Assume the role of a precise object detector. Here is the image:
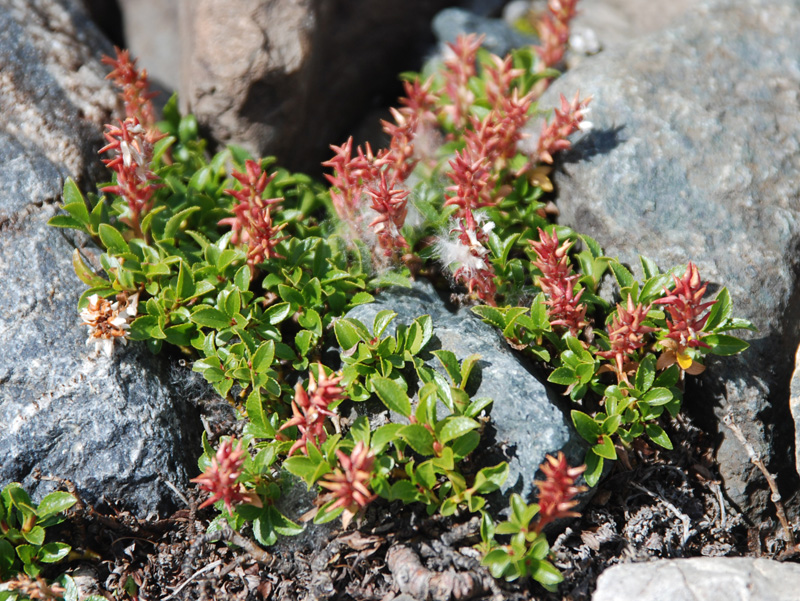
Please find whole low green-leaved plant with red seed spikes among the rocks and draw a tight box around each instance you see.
[51,7,752,588]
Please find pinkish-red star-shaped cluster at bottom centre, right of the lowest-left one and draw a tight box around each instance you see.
[319,441,375,528]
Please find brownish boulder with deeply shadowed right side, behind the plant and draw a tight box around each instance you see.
[180,0,456,172]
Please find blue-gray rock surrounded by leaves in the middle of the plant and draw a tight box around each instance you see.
[347,281,584,501]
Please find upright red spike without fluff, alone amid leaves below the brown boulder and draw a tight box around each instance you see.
[219,161,286,266]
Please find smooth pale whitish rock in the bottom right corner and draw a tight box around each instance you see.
[592,557,800,601]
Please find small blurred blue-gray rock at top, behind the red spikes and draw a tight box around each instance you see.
[433,8,536,56]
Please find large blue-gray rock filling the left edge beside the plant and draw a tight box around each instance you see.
[0,0,199,515]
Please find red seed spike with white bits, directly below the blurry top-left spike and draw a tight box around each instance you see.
[99,117,163,237]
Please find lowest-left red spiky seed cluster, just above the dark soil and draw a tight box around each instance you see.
[191,439,261,515]
